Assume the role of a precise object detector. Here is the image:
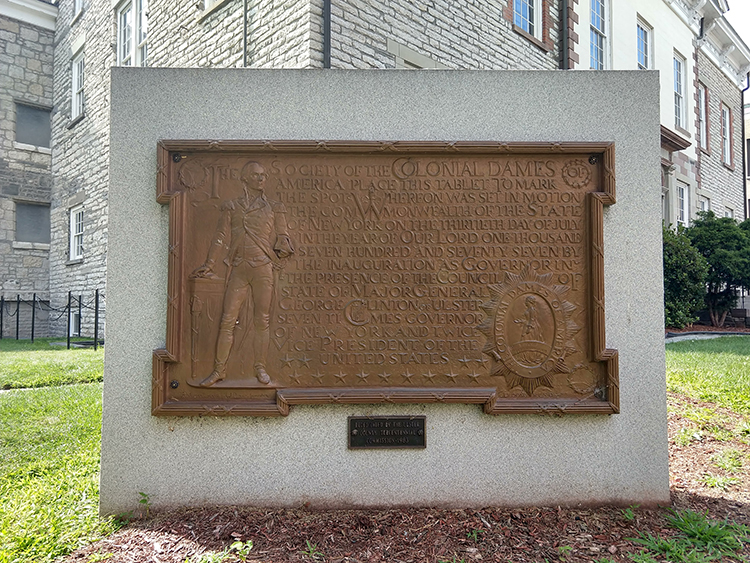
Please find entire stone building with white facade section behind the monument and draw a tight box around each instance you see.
[0,0,750,336]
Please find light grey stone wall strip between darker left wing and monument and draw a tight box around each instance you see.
[50,0,116,336]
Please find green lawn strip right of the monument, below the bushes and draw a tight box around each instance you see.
[667,336,750,414]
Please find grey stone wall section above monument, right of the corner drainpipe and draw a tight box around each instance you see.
[331,0,560,70]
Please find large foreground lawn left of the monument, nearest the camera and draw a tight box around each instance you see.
[0,383,116,563]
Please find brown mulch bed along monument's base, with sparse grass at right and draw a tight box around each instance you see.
[59,395,750,563]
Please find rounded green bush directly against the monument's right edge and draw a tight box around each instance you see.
[662,226,708,328]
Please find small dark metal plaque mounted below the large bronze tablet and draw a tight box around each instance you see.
[349,416,426,450]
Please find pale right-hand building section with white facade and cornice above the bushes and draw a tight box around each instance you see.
[574,0,750,229]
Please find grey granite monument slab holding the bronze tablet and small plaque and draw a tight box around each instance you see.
[101,68,669,513]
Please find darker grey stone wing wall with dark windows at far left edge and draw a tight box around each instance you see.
[0,12,54,335]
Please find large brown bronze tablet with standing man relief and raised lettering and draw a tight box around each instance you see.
[153,141,619,415]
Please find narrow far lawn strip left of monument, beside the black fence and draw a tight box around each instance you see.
[0,338,104,389]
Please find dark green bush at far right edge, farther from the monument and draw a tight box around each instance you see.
[686,211,750,326]
